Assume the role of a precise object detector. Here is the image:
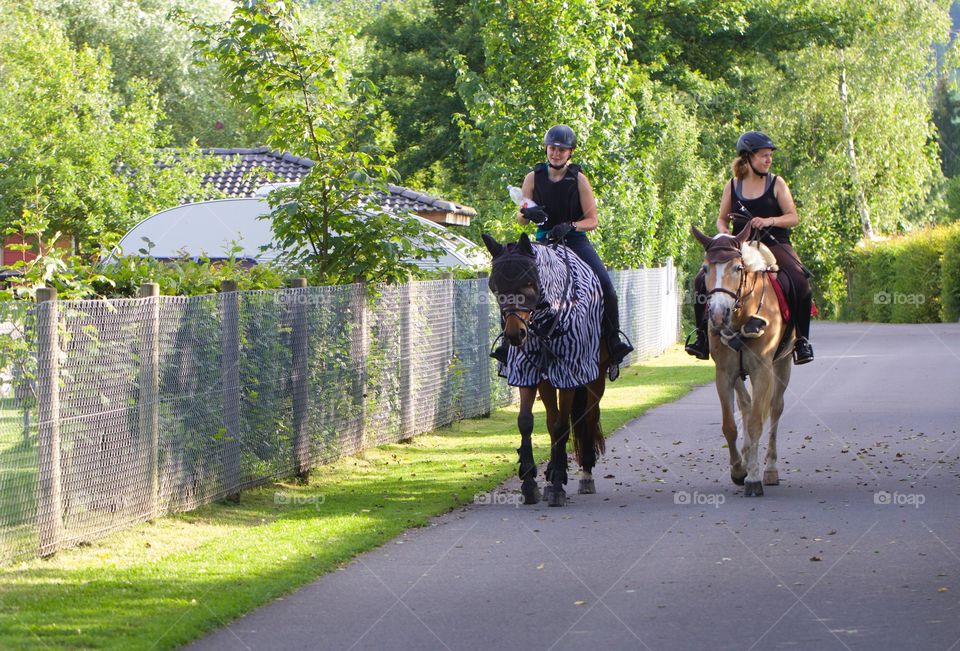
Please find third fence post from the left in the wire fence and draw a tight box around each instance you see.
[220,280,241,502]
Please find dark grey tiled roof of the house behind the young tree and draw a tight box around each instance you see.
[203,147,477,217]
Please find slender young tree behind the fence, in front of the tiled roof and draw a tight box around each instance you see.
[189,0,446,284]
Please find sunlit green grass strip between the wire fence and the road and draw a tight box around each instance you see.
[0,347,713,649]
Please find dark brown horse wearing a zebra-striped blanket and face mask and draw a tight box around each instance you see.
[483,234,607,506]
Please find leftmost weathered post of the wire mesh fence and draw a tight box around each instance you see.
[36,288,63,558]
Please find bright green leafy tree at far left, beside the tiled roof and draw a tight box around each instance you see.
[0,0,218,255]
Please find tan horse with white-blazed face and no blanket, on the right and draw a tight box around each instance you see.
[693,225,793,497]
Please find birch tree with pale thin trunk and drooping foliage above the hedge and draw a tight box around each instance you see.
[757,0,949,314]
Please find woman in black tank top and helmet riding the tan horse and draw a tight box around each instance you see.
[686,131,813,364]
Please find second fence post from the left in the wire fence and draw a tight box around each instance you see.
[140,283,160,520]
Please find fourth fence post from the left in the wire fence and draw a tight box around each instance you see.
[287,278,310,481]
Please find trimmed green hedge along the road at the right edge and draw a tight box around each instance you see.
[840,224,960,323]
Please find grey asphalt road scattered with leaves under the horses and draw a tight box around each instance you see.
[193,324,960,651]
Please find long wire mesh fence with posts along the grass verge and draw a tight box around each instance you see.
[0,265,680,563]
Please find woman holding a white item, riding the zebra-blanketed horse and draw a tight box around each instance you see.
[491,124,633,366]
